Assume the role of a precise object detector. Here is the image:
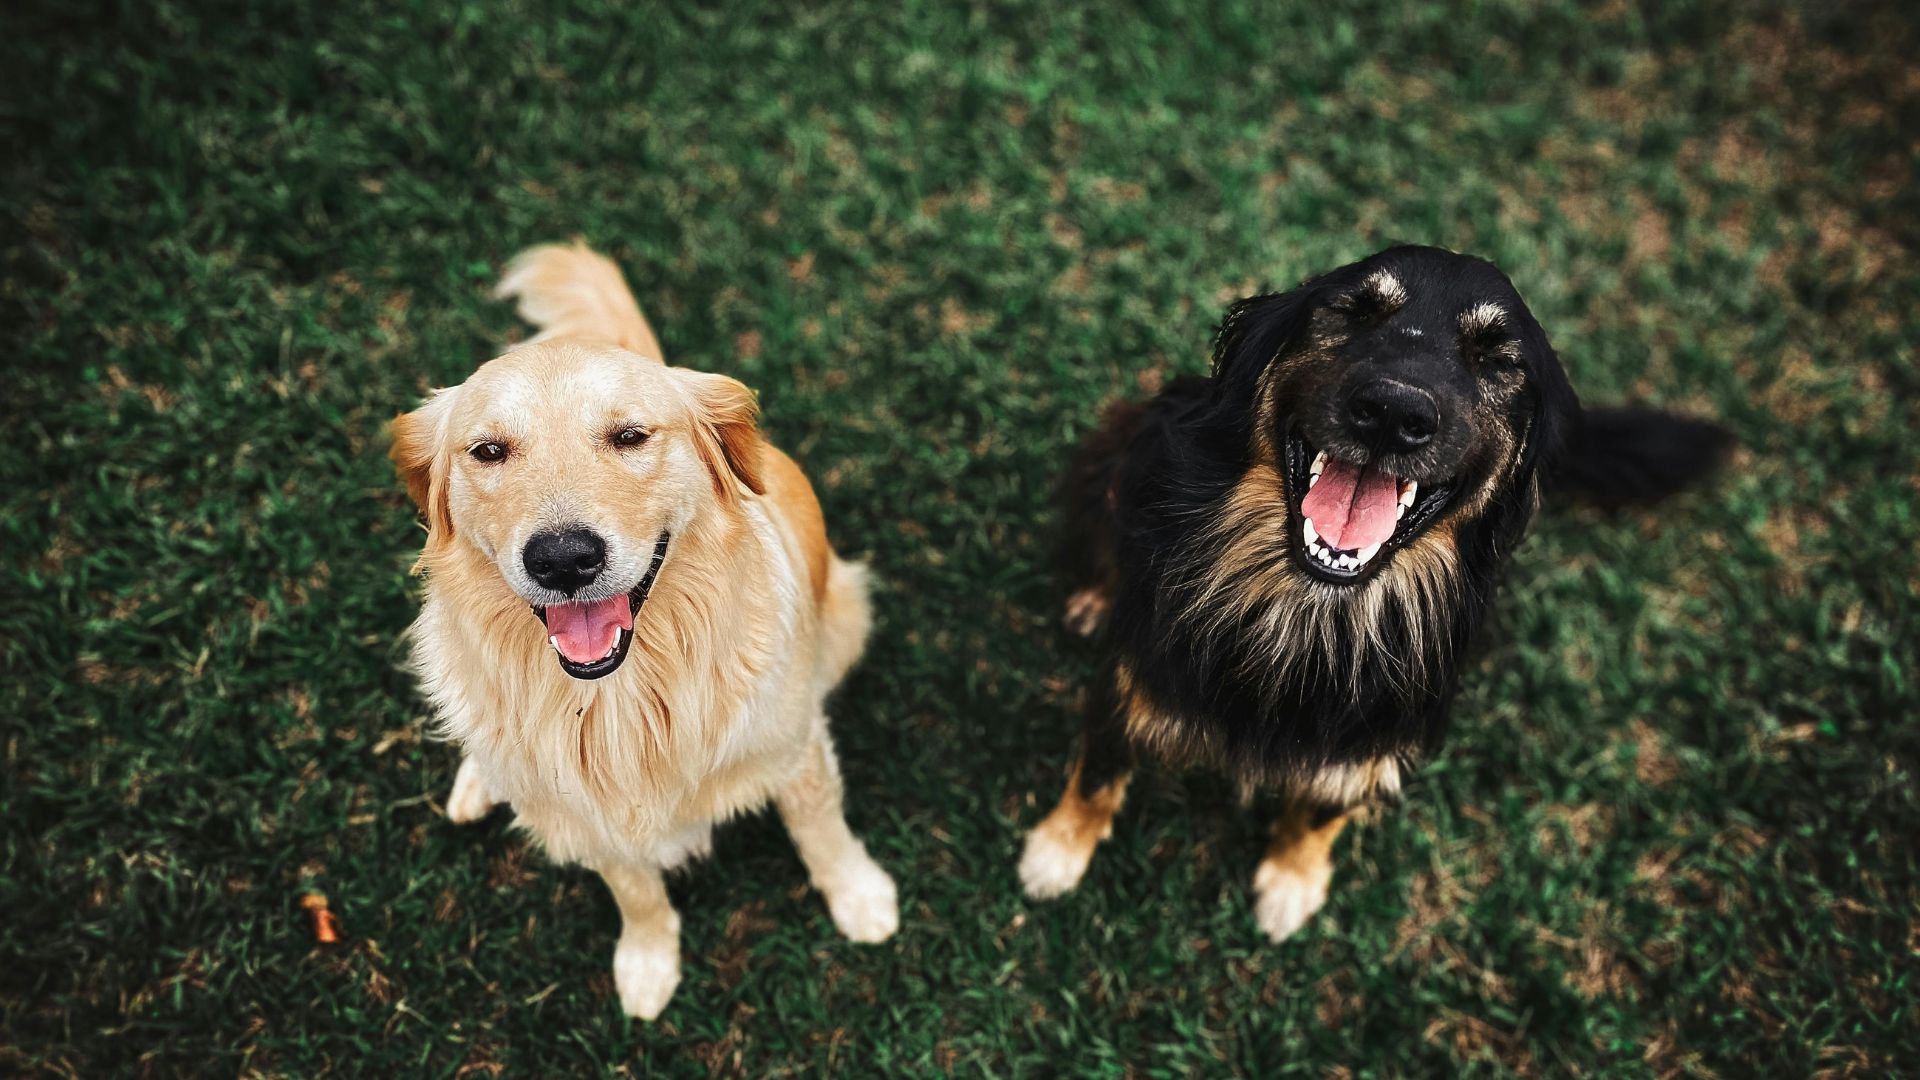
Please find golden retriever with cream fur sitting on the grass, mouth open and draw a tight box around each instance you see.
[392,244,899,1019]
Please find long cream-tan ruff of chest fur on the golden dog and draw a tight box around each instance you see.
[415,507,820,865]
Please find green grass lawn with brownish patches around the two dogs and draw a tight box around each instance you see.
[0,0,1920,1076]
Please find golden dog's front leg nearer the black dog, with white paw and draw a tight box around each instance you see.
[774,732,900,942]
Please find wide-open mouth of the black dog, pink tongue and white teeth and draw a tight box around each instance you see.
[1286,436,1452,584]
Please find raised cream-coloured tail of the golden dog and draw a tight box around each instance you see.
[493,240,666,363]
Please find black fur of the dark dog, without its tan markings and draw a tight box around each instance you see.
[1060,248,1726,799]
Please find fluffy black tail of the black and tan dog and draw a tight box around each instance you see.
[1553,409,1734,503]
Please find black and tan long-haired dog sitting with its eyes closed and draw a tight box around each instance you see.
[1020,248,1728,940]
